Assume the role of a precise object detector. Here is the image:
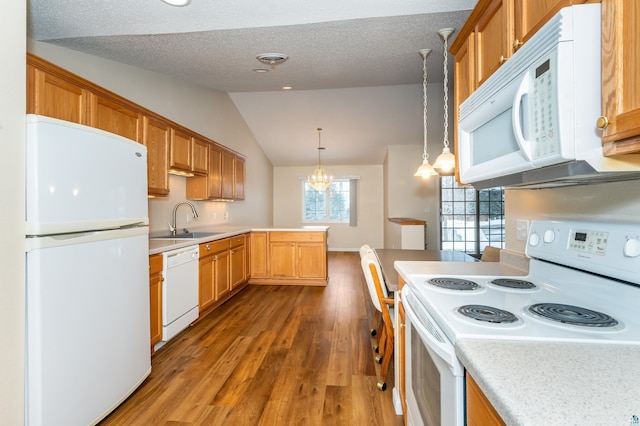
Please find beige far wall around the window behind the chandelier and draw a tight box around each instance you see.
[273,165,384,251]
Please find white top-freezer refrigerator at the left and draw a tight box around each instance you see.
[25,115,151,426]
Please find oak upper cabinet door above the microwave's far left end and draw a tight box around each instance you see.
[476,0,513,87]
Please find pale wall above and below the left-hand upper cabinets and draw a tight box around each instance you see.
[29,40,273,232]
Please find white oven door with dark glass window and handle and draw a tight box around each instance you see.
[402,285,465,426]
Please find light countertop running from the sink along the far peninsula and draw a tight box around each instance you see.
[149,225,329,255]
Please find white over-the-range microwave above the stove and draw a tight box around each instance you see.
[457,4,640,189]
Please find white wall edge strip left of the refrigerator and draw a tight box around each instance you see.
[0,0,27,425]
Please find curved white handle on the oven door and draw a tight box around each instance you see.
[402,286,464,376]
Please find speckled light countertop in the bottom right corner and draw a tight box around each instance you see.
[456,339,640,426]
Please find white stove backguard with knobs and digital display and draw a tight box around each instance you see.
[525,220,640,284]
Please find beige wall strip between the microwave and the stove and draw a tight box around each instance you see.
[505,181,640,253]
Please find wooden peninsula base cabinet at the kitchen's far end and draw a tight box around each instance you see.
[249,231,327,286]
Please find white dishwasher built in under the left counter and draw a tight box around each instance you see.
[161,245,199,347]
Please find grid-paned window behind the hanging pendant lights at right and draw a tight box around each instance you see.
[440,176,504,256]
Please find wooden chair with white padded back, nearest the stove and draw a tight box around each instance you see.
[361,251,395,391]
